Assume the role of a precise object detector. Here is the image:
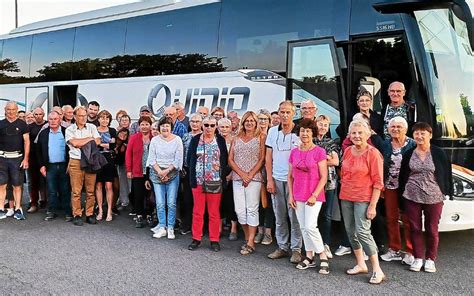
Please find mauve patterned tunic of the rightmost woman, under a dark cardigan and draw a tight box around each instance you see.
[403,152,444,204]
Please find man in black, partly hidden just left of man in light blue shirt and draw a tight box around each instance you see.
[28,107,46,213]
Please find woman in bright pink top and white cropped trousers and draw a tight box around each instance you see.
[288,119,329,274]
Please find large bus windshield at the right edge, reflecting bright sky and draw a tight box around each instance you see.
[415,9,474,139]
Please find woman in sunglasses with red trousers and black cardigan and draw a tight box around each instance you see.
[187,116,228,252]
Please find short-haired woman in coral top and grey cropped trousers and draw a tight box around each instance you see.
[339,120,385,284]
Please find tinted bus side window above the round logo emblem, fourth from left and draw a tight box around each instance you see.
[125,4,223,76]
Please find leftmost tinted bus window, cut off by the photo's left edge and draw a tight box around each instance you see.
[0,36,31,83]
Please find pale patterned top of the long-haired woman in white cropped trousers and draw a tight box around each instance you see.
[232,137,262,182]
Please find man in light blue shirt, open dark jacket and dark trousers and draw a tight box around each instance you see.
[36,111,72,222]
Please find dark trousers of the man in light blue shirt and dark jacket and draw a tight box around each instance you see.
[46,162,71,215]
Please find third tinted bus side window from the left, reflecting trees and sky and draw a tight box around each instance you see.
[72,20,127,79]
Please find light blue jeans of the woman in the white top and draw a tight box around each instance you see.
[153,176,179,228]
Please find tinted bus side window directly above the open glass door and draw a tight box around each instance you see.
[219,0,350,75]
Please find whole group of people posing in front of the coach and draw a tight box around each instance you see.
[0,82,452,284]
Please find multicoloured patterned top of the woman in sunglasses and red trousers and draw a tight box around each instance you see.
[196,136,221,185]
